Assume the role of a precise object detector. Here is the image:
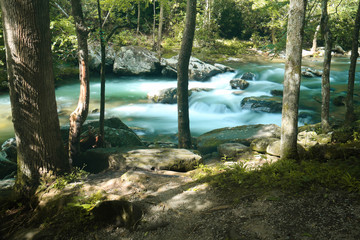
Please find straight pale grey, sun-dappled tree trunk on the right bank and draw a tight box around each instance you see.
[281,0,306,159]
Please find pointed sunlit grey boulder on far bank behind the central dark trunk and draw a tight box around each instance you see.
[162,56,225,81]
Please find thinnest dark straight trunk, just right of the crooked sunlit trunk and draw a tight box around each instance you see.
[97,0,105,147]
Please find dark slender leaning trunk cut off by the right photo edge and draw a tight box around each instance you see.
[345,1,360,124]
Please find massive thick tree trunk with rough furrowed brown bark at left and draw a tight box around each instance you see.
[1,0,69,196]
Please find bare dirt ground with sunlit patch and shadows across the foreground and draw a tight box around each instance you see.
[0,165,360,240]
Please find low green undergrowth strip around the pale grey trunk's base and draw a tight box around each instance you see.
[193,158,360,194]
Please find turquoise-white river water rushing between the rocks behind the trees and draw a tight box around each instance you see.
[0,58,360,142]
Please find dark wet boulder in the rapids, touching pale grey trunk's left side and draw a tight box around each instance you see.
[241,96,282,113]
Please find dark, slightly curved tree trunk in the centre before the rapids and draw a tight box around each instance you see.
[177,0,196,148]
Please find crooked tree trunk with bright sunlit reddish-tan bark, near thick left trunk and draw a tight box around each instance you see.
[69,0,90,164]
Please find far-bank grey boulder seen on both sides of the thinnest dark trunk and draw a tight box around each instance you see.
[89,43,116,72]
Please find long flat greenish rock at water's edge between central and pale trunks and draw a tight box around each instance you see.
[197,124,280,154]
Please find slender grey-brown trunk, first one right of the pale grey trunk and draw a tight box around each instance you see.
[321,0,332,132]
